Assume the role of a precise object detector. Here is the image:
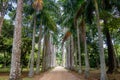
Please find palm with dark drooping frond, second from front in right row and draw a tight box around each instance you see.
[74,2,90,75]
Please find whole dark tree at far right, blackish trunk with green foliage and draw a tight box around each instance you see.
[101,0,120,73]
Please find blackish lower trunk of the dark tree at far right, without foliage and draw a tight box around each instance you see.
[105,27,117,73]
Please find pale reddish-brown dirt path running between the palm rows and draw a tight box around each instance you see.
[34,67,83,80]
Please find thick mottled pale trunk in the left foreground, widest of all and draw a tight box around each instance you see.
[9,0,23,80]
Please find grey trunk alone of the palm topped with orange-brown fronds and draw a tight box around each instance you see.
[28,15,36,77]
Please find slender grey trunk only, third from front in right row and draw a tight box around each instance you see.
[77,21,82,74]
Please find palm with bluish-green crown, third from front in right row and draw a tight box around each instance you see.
[62,0,82,73]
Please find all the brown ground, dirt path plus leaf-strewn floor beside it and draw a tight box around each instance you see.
[0,66,120,80]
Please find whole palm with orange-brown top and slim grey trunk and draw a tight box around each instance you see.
[28,0,43,77]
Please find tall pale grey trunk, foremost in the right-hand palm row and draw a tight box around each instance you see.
[94,0,107,80]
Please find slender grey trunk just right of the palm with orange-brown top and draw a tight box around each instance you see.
[36,23,42,74]
